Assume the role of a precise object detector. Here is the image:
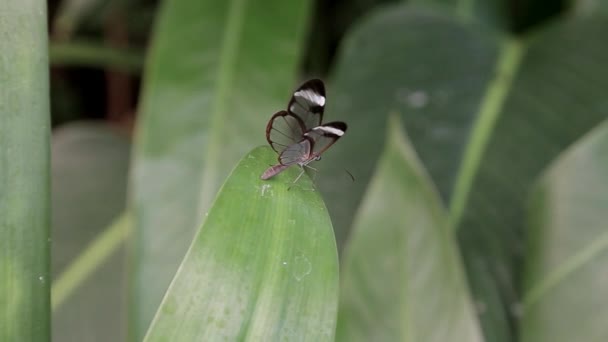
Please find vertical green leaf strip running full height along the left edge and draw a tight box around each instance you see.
[0,0,51,341]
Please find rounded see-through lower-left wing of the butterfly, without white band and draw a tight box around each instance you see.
[266,110,305,153]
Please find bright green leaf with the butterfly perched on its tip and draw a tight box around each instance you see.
[146,147,338,341]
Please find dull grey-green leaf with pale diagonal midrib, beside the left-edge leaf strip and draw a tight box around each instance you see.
[51,121,130,342]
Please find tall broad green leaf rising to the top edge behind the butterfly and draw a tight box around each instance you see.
[130,0,309,340]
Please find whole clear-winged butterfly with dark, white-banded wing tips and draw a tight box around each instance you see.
[261,79,346,183]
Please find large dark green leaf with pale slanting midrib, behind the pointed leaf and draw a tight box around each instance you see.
[319,5,608,341]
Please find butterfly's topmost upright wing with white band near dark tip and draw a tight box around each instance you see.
[287,79,325,131]
